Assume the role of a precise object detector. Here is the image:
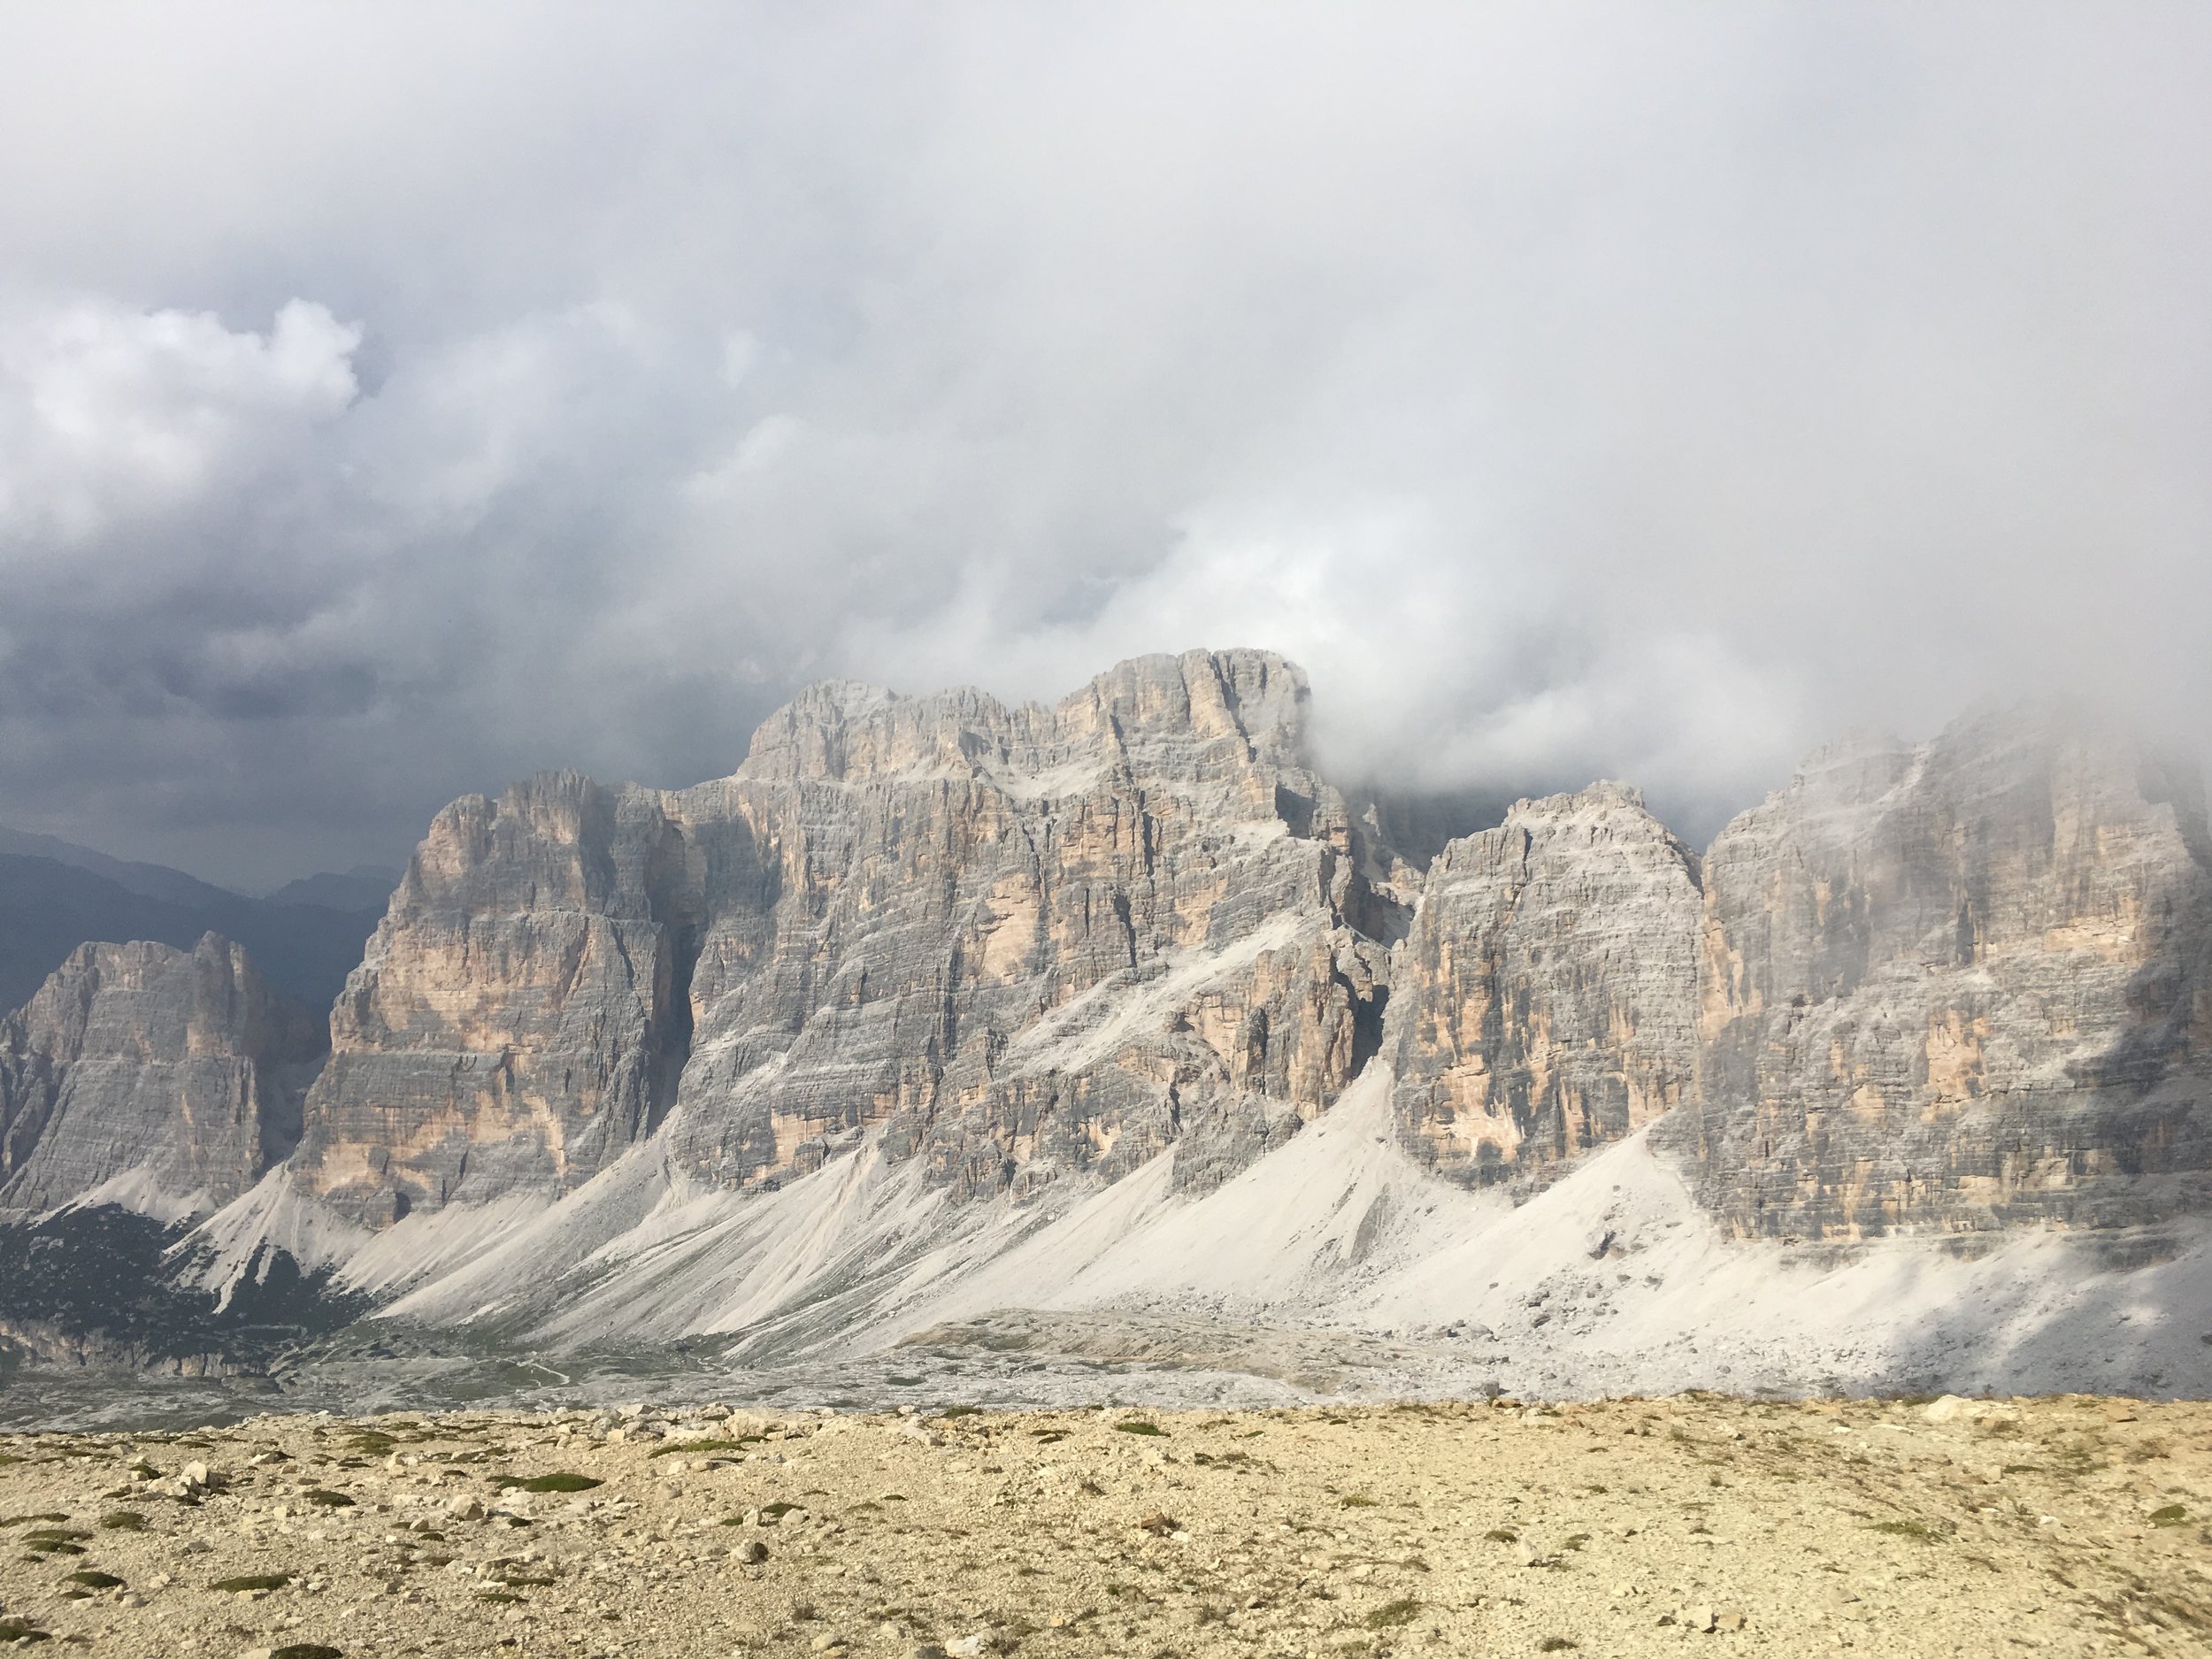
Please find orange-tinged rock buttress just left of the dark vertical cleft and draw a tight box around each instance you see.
[299,772,688,1221]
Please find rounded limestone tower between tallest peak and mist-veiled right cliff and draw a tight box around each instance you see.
[1385,783,1701,1184]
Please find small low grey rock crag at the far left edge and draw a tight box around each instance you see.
[0,933,323,1212]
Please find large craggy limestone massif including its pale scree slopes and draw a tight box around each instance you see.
[4,650,2212,1394]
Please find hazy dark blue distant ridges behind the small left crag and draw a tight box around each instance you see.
[0,849,383,1009]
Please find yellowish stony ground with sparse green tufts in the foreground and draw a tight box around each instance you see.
[0,1396,2212,1659]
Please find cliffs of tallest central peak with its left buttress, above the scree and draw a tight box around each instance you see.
[295,653,1396,1221]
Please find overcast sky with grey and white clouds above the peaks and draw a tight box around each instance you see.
[0,0,2212,889]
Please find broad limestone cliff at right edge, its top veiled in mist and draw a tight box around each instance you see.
[1663,708,2212,1239]
